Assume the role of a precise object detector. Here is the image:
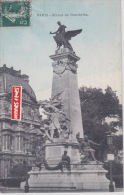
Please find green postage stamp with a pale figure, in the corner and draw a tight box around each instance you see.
[0,0,31,27]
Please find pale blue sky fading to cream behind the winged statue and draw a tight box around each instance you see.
[0,0,122,101]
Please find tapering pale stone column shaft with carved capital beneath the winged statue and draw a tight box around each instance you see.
[50,48,83,142]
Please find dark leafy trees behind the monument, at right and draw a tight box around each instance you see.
[79,86,123,160]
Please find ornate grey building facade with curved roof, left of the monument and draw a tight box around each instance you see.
[0,65,41,178]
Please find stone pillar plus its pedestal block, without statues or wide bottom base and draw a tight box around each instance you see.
[43,48,83,164]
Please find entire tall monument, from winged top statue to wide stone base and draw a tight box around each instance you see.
[22,22,109,192]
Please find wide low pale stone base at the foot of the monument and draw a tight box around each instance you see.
[21,164,109,192]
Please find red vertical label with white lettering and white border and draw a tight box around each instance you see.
[11,86,22,120]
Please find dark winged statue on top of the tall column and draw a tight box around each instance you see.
[50,22,82,51]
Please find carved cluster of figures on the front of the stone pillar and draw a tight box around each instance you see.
[39,93,70,142]
